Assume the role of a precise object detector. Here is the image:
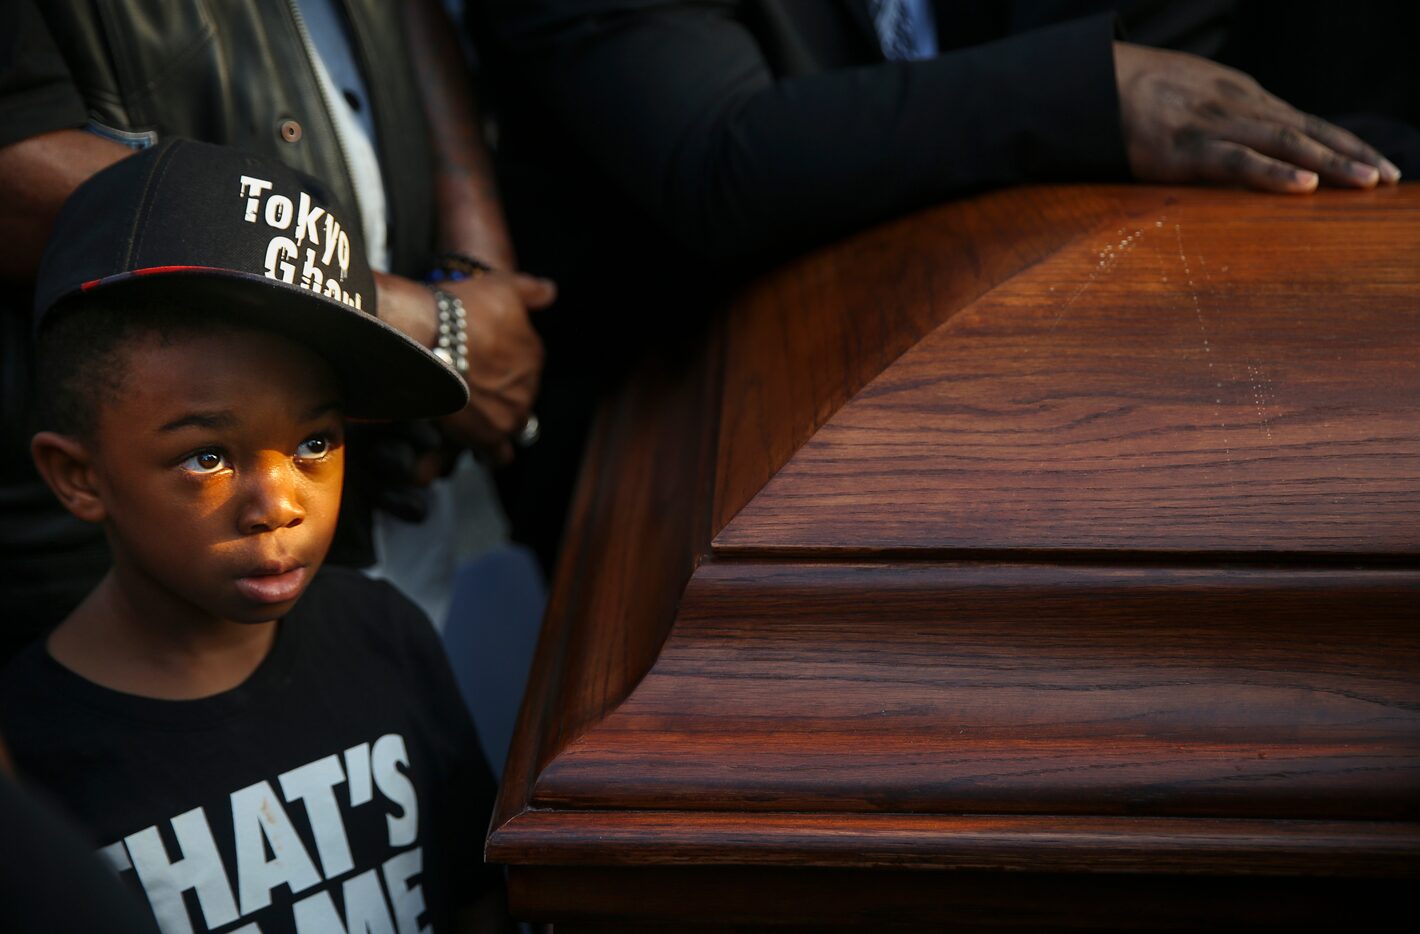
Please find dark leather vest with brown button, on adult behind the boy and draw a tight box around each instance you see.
[36,0,433,277]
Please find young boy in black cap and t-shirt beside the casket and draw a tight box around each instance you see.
[0,141,508,934]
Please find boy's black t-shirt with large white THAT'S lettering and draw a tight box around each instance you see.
[0,568,497,934]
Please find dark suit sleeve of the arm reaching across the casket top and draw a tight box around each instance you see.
[482,0,1125,258]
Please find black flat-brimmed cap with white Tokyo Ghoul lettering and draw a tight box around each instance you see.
[34,139,469,419]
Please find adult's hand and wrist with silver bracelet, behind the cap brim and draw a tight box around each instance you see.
[376,265,557,464]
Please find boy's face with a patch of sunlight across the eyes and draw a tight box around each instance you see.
[91,328,345,623]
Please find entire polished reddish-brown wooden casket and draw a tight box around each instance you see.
[487,186,1420,931]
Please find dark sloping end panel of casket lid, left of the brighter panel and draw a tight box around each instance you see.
[714,186,1137,531]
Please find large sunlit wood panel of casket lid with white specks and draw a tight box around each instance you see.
[716,187,1420,555]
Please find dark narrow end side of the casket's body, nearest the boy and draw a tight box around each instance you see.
[493,320,721,826]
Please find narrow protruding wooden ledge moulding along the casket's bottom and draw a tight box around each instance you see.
[493,811,1417,879]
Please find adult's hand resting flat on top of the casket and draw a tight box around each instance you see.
[1115,43,1400,193]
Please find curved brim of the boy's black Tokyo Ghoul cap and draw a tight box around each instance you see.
[70,267,469,419]
